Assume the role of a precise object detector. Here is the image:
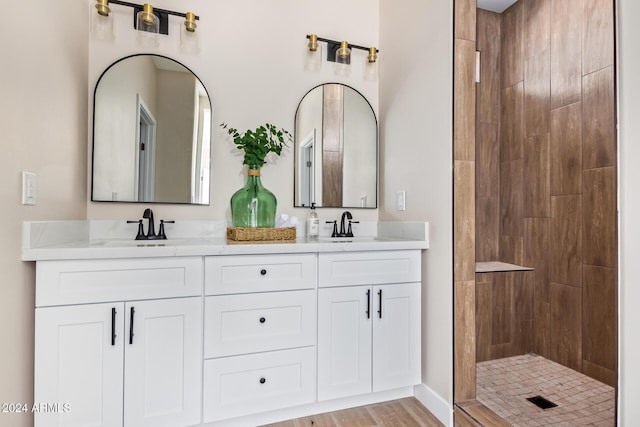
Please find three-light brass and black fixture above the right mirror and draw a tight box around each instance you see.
[306,34,380,78]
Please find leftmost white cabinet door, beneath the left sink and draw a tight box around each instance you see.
[34,303,124,427]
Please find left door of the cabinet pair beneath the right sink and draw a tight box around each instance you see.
[318,286,374,400]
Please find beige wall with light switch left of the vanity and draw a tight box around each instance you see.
[0,0,88,427]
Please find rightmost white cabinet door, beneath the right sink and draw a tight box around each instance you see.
[372,283,421,391]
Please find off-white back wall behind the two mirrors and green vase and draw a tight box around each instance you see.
[87,0,379,227]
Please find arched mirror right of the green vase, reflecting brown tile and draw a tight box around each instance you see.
[294,83,378,208]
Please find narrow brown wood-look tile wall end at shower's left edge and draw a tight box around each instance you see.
[453,0,478,401]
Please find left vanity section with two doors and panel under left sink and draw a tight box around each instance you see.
[34,257,202,427]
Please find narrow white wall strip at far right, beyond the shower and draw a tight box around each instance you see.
[617,0,640,426]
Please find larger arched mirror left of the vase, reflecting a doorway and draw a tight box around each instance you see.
[91,55,212,205]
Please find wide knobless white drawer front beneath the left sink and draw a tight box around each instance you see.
[36,257,203,307]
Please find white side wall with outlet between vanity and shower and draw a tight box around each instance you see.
[380,0,453,422]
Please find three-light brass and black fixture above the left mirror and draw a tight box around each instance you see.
[91,0,200,46]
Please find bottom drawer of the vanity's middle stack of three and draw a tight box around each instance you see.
[203,347,316,422]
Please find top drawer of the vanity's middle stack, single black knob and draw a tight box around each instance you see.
[205,254,316,295]
